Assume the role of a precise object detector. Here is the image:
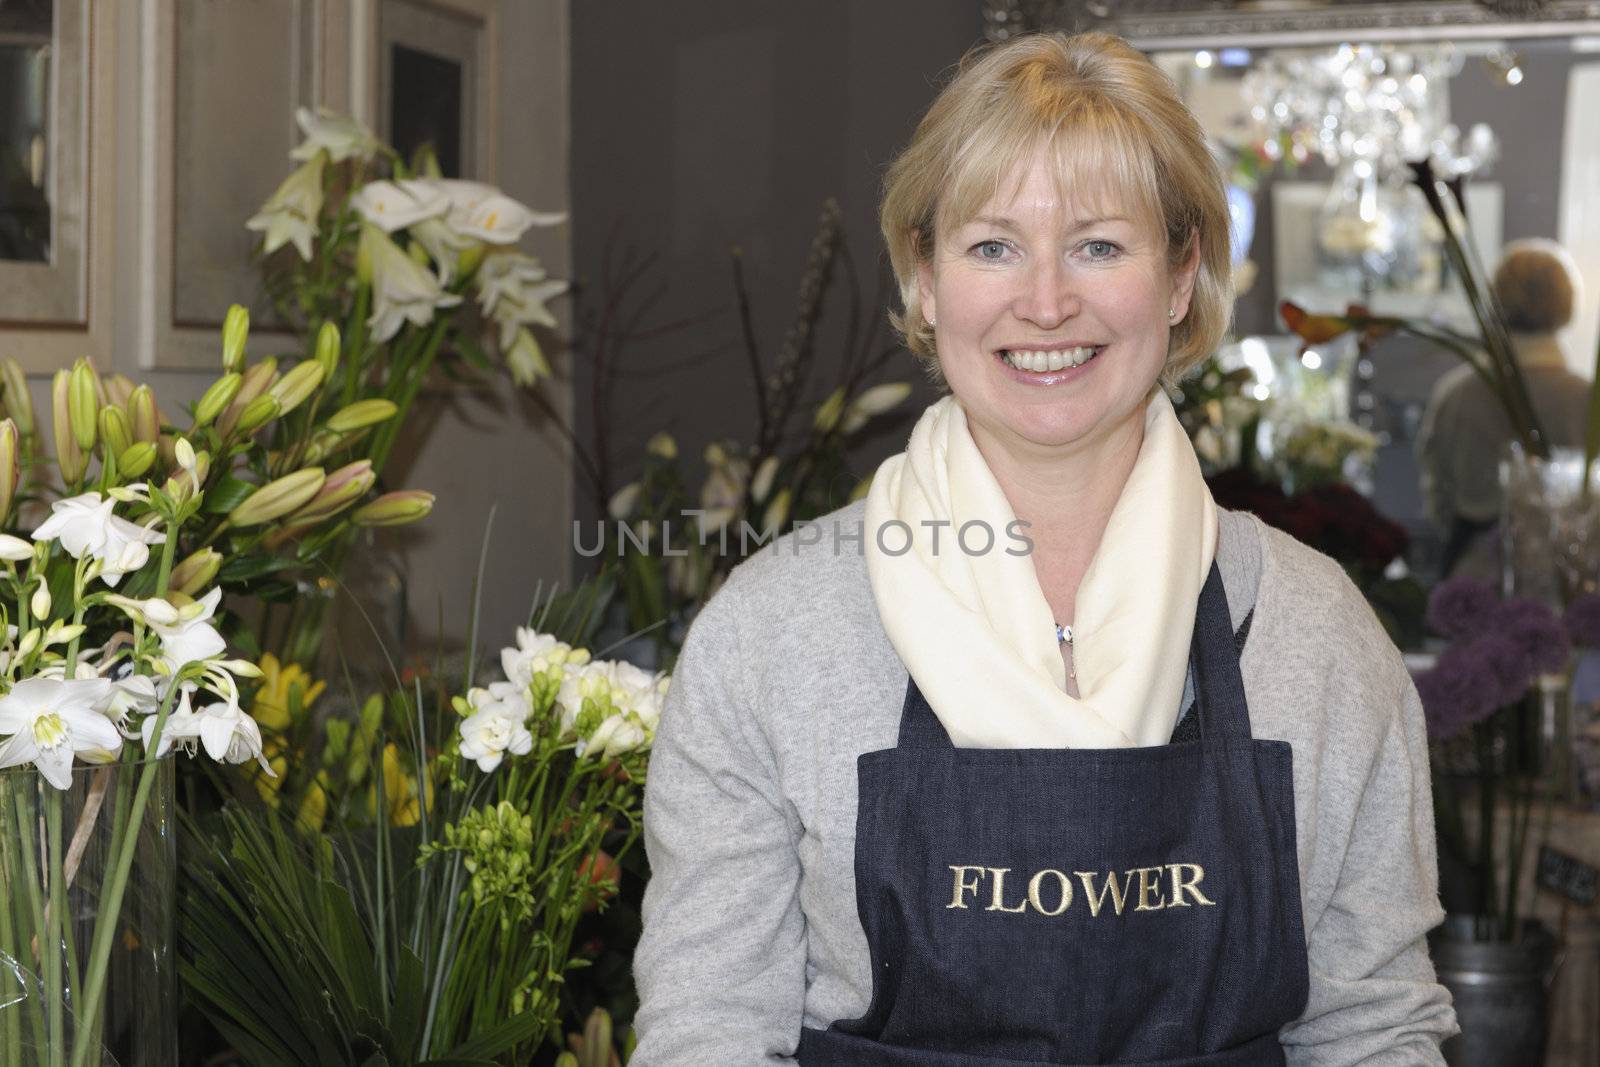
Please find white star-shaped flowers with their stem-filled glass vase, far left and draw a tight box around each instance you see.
[0,447,270,1067]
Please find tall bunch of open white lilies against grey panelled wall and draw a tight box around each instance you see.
[246,109,566,667]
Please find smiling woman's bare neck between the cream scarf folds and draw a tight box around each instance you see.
[973,406,1144,624]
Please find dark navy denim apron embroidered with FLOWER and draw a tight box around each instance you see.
[798,565,1309,1067]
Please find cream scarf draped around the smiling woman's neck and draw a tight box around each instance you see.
[866,389,1216,749]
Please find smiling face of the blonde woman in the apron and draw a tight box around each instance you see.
[918,154,1198,454]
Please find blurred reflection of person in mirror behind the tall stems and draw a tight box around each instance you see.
[1416,238,1589,577]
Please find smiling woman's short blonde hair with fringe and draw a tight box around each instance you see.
[878,34,1234,381]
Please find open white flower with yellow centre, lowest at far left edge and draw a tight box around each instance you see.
[0,678,122,789]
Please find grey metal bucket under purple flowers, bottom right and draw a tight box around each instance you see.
[1429,915,1555,1067]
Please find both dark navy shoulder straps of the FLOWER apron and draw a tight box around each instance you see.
[899,561,1250,749]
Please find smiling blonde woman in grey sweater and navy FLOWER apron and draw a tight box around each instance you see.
[632,35,1454,1067]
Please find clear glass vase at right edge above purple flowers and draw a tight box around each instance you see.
[1501,445,1600,609]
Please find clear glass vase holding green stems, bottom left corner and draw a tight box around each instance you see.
[0,757,178,1067]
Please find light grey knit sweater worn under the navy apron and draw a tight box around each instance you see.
[630,502,1456,1067]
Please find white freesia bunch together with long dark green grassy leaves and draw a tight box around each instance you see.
[179,620,667,1067]
